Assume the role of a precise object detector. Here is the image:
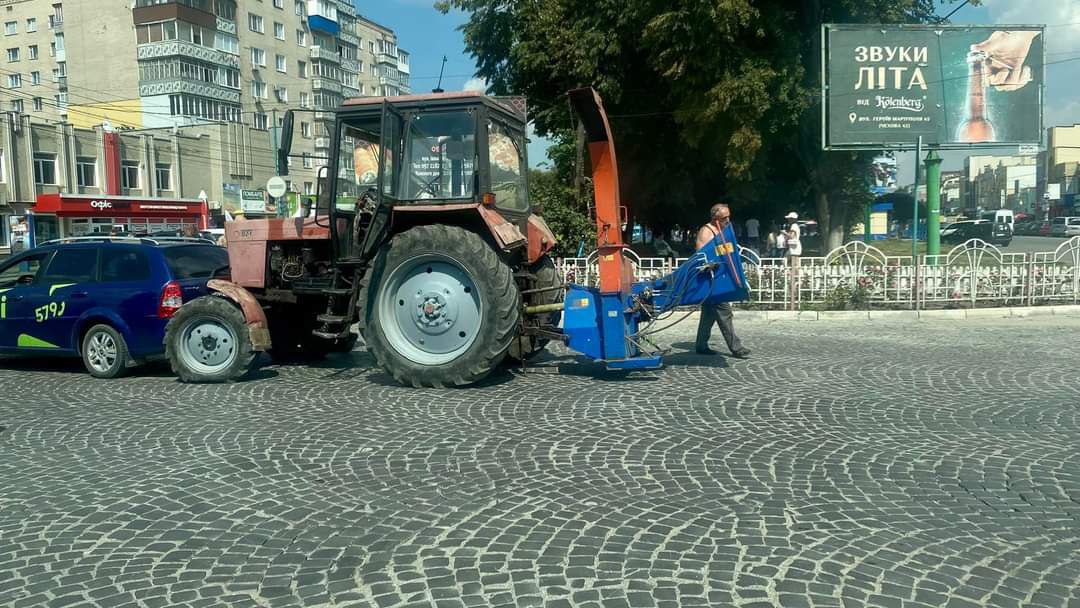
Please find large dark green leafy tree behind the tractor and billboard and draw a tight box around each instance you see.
[436,0,972,246]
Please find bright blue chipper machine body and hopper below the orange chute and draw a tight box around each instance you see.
[563,226,750,369]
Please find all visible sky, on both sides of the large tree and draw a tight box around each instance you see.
[356,0,1080,179]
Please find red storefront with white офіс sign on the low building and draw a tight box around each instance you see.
[32,194,207,243]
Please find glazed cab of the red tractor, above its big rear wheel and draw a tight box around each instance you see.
[285,93,529,264]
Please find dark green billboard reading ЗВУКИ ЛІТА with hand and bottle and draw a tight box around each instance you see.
[822,25,1044,150]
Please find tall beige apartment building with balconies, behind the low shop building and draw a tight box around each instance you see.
[0,0,409,198]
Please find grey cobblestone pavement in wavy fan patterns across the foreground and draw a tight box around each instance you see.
[0,316,1080,608]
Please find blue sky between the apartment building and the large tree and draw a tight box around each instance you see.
[356,0,550,166]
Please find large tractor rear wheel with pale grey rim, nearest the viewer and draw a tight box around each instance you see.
[361,225,521,387]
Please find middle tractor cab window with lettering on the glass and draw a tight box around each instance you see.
[402,110,476,200]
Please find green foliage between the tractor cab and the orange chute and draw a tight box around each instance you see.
[529,171,596,256]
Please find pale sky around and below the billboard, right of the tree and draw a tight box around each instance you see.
[896,0,1080,186]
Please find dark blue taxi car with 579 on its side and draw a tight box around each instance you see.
[0,238,229,378]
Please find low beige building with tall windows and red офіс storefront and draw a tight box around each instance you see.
[0,112,274,256]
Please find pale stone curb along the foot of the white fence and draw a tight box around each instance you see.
[725,306,1080,323]
